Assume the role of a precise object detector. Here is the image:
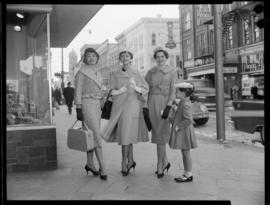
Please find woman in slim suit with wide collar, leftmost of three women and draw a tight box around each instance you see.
[75,48,107,180]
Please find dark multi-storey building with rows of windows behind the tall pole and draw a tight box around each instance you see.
[180,1,264,98]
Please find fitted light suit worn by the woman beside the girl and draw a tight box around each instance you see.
[145,66,177,144]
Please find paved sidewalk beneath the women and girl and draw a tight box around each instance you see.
[7,106,265,205]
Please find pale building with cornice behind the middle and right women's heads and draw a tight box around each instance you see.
[115,16,180,75]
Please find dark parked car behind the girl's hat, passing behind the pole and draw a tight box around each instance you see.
[182,79,232,110]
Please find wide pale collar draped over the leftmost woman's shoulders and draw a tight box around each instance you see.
[79,63,102,88]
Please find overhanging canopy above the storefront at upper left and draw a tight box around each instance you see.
[7,4,103,48]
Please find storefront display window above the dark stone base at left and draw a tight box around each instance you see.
[6,11,51,126]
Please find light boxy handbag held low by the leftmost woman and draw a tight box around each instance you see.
[67,120,95,152]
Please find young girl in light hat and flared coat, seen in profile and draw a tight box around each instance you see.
[169,83,197,182]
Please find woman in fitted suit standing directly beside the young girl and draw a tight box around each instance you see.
[145,48,177,178]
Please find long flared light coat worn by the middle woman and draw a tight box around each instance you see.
[102,69,149,145]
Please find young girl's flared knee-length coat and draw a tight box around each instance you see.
[168,99,197,149]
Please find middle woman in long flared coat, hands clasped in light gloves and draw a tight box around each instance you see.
[102,51,149,176]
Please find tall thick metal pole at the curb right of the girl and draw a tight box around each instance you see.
[212,4,225,141]
